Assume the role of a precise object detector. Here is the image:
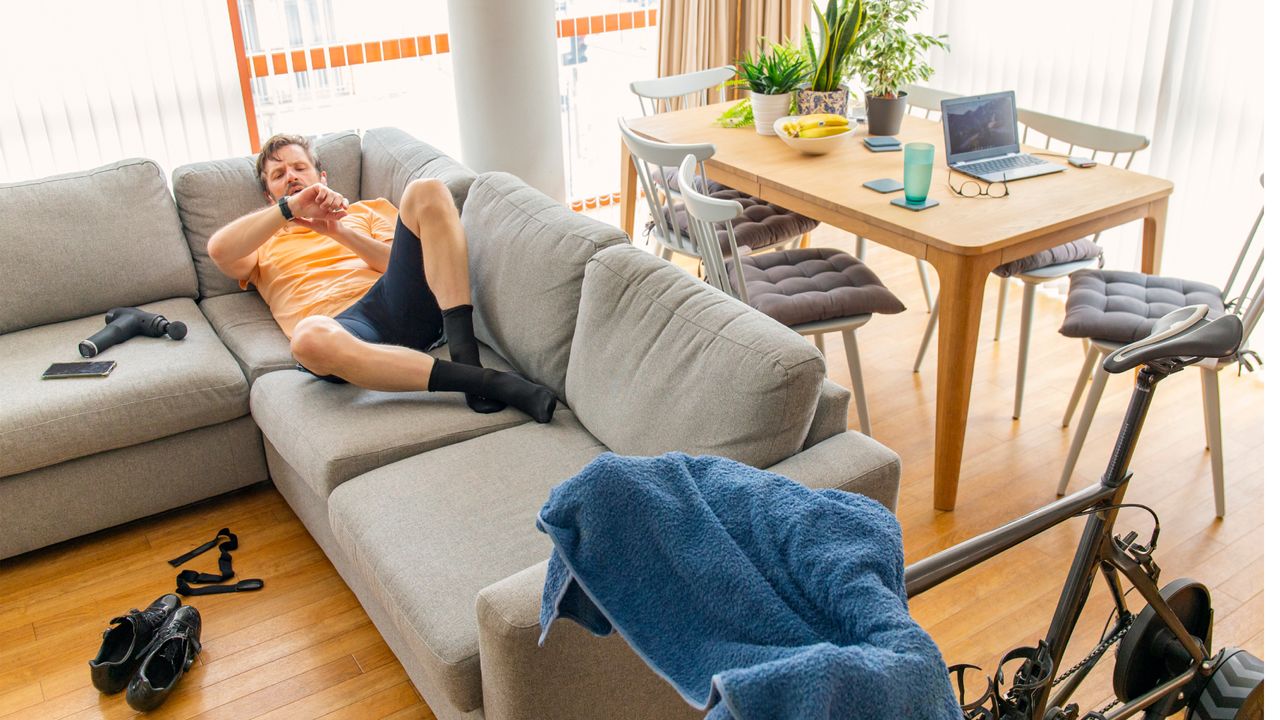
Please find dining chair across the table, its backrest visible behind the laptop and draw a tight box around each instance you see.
[914,108,1149,420]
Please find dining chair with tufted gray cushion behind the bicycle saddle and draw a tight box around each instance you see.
[1057,181,1263,518]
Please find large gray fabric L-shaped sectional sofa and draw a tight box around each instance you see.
[0,128,899,720]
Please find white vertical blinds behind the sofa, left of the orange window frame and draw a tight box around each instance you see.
[0,0,250,182]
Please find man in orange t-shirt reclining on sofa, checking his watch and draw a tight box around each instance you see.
[209,135,556,423]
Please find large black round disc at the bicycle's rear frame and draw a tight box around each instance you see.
[1111,578,1213,711]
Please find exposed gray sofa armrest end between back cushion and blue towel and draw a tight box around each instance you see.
[765,432,902,510]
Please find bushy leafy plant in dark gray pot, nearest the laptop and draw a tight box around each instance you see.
[852,0,948,135]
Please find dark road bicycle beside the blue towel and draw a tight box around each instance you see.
[906,305,1262,720]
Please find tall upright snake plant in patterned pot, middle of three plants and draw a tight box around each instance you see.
[796,0,863,115]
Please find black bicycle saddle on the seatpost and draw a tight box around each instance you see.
[1102,305,1244,373]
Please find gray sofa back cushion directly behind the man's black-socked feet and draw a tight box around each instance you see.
[462,173,627,400]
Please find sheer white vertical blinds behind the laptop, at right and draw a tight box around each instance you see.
[923,0,1263,284]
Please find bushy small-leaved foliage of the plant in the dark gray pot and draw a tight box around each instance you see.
[851,0,950,97]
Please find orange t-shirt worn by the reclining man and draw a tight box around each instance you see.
[241,197,397,338]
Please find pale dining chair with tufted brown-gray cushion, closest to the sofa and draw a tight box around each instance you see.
[676,152,905,436]
